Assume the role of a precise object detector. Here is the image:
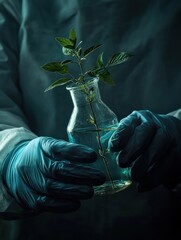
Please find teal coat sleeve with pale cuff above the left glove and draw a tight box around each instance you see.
[0,0,36,212]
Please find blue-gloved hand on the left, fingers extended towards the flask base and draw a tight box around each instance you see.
[2,137,105,212]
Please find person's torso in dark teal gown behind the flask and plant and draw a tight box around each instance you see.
[4,0,181,240]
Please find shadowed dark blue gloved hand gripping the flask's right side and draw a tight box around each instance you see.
[109,110,181,191]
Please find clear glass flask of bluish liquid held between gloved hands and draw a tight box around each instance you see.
[66,78,131,195]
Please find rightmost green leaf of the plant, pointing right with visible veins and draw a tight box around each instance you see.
[106,52,133,67]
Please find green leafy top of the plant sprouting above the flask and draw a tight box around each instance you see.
[42,29,133,92]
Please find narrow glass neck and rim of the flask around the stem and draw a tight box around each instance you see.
[67,78,101,107]
